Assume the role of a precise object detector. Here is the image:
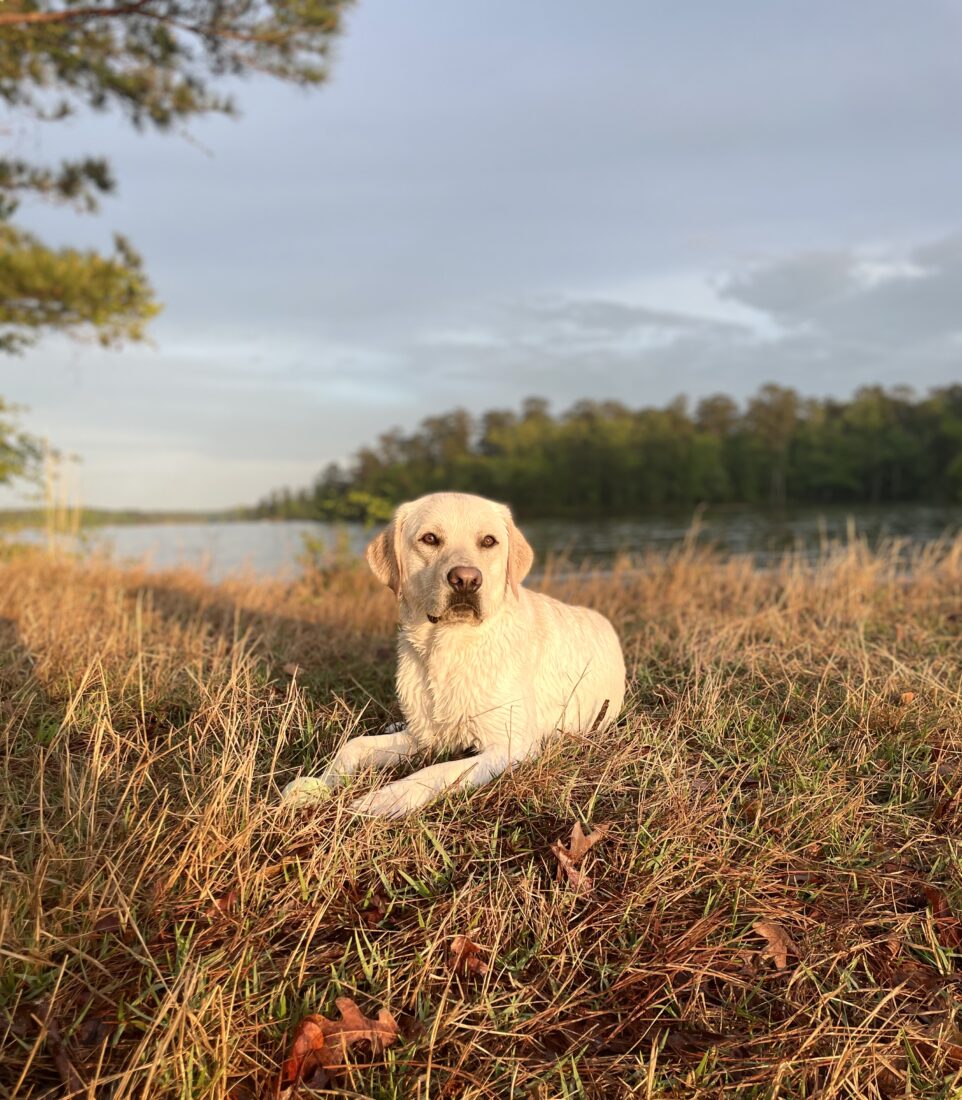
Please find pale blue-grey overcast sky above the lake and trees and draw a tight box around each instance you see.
[0,0,962,508]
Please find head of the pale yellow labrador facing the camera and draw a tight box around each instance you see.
[367,493,534,624]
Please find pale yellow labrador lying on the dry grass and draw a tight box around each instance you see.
[284,493,624,817]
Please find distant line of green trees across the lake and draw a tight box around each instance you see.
[252,385,962,520]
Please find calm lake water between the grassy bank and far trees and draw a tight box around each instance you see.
[5,505,962,580]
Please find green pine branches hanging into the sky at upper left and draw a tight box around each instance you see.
[0,0,346,352]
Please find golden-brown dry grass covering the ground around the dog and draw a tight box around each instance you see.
[0,536,962,1100]
